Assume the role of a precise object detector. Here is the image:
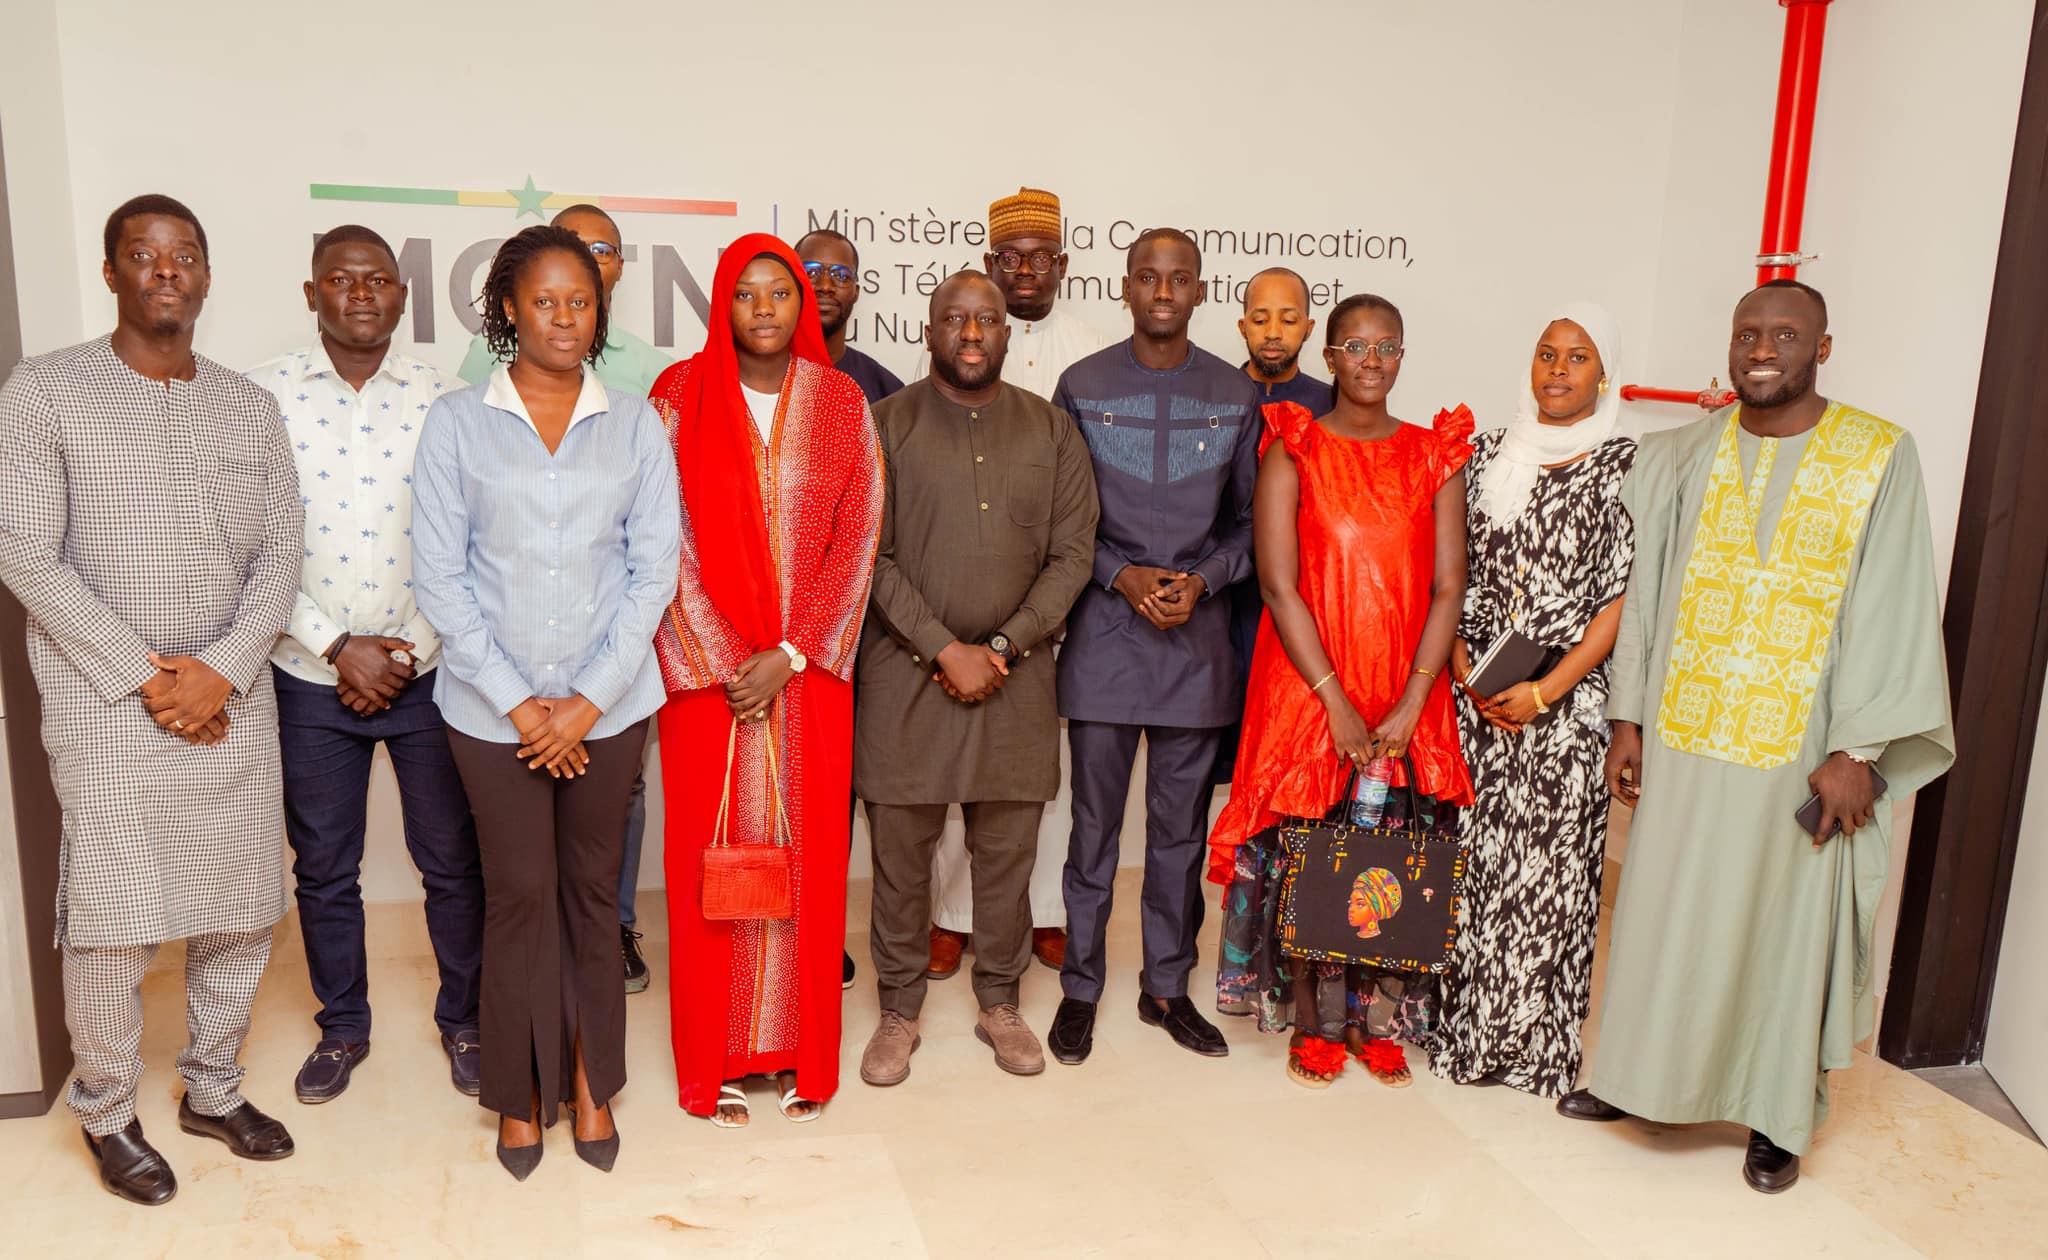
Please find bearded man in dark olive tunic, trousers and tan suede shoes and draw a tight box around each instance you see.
[854,270,1098,1086]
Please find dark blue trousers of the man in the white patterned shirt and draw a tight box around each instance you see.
[272,670,483,1043]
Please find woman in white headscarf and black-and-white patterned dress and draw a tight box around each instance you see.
[1430,303,1636,1098]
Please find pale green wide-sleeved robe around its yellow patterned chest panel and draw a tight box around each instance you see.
[1587,412,1956,1153]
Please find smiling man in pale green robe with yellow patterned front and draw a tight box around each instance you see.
[1559,281,1956,1192]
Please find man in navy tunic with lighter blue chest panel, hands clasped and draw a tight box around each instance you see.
[1047,227,1264,1063]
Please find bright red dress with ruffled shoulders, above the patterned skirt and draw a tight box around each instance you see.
[1208,404,1473,883]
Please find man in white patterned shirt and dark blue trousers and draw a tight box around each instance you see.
[250,225,483,1102]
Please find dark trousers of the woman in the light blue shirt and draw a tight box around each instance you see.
[449,721,647,1125]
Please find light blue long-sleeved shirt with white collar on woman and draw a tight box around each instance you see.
[412,367,682,744]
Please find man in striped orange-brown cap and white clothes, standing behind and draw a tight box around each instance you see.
[918,188,1112,979]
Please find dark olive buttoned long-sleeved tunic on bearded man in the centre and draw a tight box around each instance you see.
[854,379,1100,805]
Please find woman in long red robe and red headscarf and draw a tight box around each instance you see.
[651,234,883,1127]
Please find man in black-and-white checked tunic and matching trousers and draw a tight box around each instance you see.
[0,197,305,1205]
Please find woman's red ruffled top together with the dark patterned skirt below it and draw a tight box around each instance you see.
[1208,404,1473,1044]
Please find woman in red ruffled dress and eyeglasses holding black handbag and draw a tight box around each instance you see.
[1208,293,1473,1088]
